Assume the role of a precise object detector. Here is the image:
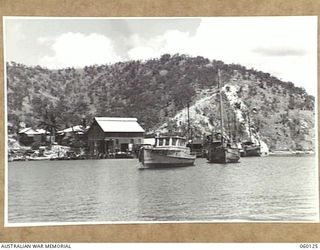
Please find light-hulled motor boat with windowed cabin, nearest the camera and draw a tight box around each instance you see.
[139,136,196,168]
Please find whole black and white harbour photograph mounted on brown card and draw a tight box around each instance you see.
[3,16,319,226]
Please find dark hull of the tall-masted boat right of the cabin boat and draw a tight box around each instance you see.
[207,147,240,163]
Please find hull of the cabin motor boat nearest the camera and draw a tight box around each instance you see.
[139,148,196,168]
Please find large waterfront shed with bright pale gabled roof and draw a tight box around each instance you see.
[87,117,144,155]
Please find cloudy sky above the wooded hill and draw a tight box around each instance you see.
[4,16,317,95]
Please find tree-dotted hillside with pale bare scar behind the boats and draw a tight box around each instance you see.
[7,54,315,150]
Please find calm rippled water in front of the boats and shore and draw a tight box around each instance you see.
[8,156,318,223]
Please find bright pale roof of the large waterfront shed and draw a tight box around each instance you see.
[94,117,144,133]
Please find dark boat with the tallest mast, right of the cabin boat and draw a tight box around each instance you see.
[207,70,240,163]
